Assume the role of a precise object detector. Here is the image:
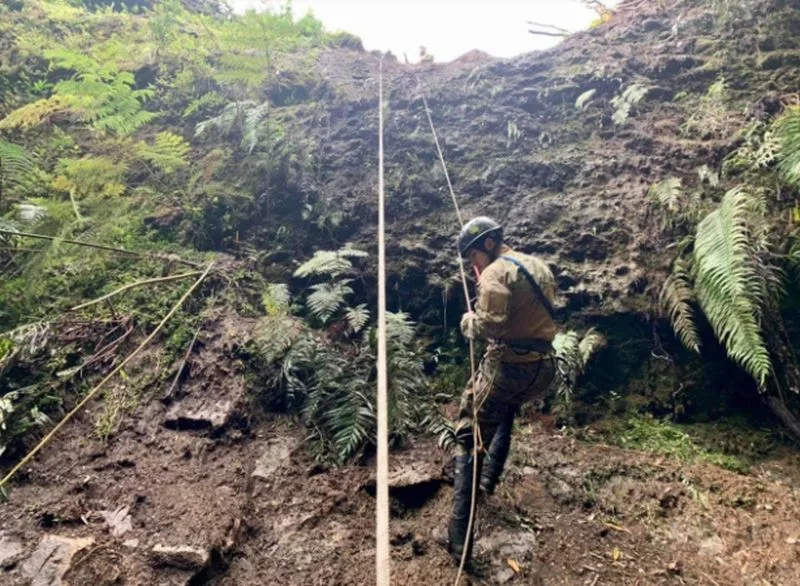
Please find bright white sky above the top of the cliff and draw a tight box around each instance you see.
[228,0,619,62]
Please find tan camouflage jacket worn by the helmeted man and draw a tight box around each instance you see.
[462,246,556,362]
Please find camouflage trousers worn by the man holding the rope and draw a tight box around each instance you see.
[455,349,556,455]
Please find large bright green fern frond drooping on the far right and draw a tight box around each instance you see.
[693,188,772,385]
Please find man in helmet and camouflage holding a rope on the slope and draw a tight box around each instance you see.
[438,217,556,560]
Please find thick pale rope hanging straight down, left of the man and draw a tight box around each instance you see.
[375,60,391,586]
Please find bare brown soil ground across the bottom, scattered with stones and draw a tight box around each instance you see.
[0,384,800,586]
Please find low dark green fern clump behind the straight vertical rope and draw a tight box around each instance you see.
[255,313,434,464]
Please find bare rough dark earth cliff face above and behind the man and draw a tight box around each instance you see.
[247,2,800,323]
